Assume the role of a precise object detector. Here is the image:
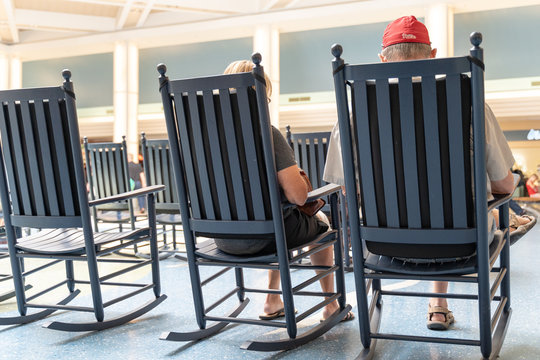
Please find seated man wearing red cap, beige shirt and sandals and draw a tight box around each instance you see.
[323,16,527,330]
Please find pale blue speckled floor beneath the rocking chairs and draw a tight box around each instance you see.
[0,214,540,360]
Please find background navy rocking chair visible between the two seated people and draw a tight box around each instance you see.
[285,125,352,271]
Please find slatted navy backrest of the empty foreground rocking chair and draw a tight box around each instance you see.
[0,71,88,228]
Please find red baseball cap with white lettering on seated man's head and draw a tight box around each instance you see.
[382,15,431,49]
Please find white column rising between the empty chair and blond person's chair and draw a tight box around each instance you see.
[113,41,139,158]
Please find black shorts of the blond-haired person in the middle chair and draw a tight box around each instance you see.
[214,207,328,255]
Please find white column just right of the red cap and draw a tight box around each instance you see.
[426,4,454,57]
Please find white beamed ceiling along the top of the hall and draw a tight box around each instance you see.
[0,0,540,45]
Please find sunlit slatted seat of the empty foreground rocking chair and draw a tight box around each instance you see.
[16,228,150,255]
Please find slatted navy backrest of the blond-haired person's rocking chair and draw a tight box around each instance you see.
[158,59,283,237]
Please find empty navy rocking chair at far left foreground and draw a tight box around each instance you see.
[0,70,166,331]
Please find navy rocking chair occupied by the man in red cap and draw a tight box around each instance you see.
[332,33,511,358]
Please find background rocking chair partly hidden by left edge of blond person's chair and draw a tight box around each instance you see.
[141,133,186,260]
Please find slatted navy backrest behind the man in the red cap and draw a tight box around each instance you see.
[336,45,487,258]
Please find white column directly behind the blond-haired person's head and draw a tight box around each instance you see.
[253,24,280,129]
